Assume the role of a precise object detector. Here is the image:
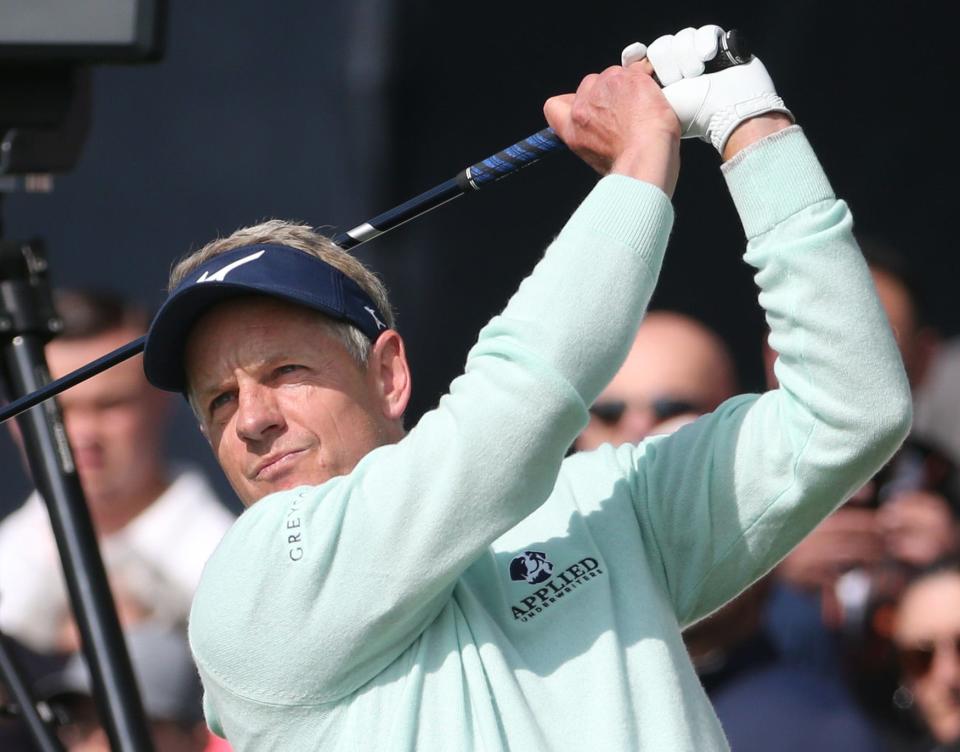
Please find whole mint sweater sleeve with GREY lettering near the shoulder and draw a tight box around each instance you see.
[190,176,673,704]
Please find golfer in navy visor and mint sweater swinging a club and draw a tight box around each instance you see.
[145,27,910,752]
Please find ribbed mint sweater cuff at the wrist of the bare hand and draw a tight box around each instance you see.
[559,175,673,263]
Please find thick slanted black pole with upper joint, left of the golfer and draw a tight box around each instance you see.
[0,232,153,752]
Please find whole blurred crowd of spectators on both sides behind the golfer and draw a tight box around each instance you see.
[0,232,960,752]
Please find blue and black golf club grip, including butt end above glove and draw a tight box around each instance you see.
[457,29,753,191]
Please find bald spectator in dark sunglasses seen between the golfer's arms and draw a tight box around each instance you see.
[574,311,737,451]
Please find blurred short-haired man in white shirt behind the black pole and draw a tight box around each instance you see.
[0,292,233,652]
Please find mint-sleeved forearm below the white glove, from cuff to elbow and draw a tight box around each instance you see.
[724,128,910,428]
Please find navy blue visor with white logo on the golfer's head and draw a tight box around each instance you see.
[143,244,387,392]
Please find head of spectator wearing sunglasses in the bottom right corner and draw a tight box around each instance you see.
[893,558,960,752]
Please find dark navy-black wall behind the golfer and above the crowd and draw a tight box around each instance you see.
[0,0,960,513]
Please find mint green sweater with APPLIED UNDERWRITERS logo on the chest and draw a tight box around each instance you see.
[190,127,910,752]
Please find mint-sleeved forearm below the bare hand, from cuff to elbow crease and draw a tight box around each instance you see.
[484,175,673,406]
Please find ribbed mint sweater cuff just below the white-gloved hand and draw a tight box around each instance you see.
[721,125,836,240]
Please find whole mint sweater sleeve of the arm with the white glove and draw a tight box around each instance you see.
[626,126,910,624]
